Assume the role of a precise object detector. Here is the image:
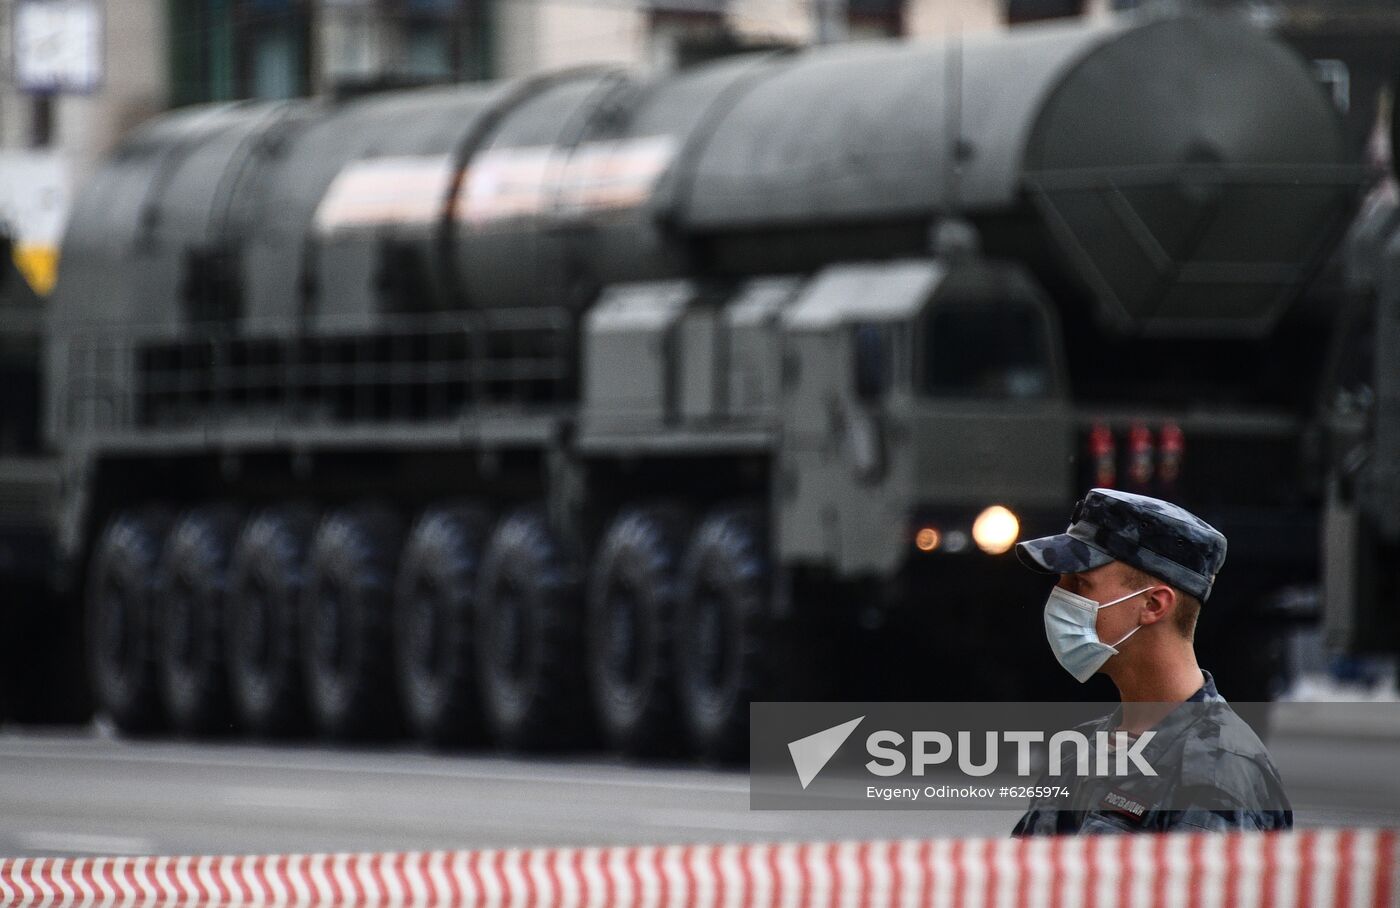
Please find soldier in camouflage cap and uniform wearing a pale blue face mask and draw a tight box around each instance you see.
[1012,488,1294,835]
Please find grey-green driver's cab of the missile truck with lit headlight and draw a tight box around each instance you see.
[776,259,1072,578]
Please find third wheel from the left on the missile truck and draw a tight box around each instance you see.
[224,506,315,737]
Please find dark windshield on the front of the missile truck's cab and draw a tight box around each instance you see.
[923,302,1054,400]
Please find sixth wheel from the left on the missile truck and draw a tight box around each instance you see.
[476,508,588,750]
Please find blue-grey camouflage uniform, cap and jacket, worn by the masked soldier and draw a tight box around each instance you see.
[1014,488,1294,835]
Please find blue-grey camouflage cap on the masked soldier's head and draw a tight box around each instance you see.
[1016,488,1225,602]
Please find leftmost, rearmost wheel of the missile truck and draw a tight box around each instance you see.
[87,508,169,733]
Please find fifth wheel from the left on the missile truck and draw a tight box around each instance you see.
[393,505,491,746]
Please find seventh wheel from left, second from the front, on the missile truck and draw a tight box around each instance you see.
[588,506,687,756]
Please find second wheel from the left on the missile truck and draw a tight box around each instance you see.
[155,506,238,735]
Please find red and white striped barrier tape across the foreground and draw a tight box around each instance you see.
[0,830,1400,908]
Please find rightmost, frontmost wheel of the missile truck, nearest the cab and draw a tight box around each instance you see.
[676,508,770,760]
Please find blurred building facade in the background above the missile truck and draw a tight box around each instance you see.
[0,0,1397,293]
